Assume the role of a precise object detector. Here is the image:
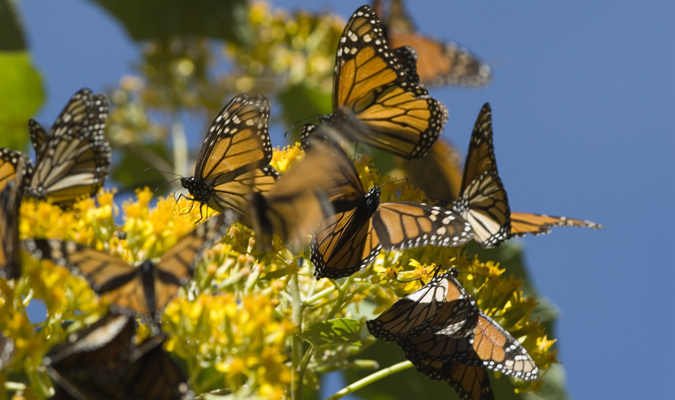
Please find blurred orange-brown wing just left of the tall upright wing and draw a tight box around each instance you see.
[401,138,462,207]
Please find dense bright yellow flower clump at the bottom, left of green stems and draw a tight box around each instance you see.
[162,293,295,399]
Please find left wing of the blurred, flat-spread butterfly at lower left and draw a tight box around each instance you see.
[24,239,155,318]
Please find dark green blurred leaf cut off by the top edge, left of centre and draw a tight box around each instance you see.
[89,0,252,44]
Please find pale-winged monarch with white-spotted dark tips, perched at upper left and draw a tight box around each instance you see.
[24,89,111,207]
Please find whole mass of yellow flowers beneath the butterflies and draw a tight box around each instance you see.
[0,144,557,399]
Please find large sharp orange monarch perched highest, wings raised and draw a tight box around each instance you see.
[301,6,448,159]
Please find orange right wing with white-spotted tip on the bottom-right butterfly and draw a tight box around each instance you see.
[473,313,539,381]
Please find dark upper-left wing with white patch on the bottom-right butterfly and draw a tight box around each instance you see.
[366,268,478,342]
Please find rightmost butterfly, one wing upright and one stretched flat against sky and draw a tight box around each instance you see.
[452,103,602,247]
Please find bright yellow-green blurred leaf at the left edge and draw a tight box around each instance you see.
[0,51,44,150]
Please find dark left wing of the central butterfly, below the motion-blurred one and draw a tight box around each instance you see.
[309,206,382,279]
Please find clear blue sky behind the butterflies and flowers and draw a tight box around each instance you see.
[20,0,675,399]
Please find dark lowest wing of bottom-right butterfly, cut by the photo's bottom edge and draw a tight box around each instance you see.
[411,359,495,400]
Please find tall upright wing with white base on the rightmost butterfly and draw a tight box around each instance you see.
[453,103,511,247]
